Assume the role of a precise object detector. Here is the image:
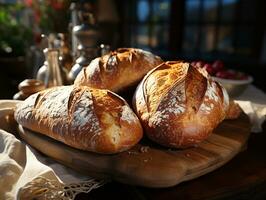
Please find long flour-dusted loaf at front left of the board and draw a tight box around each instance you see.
[15,86,142,154]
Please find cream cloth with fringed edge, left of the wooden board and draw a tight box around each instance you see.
[0,100,105,200]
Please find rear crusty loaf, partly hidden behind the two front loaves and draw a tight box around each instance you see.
[74,48,163,92]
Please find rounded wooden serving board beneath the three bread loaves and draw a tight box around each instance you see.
[18,114,250,187]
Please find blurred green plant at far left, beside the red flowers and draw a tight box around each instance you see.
[0,3,32,56]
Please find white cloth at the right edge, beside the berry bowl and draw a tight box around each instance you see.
[235,85,266,132]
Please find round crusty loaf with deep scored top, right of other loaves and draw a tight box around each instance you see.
[133,61,229,148]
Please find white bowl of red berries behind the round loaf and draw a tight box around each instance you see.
[191,60,253,97]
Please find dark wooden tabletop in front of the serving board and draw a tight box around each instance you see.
[76,122,266,200]
